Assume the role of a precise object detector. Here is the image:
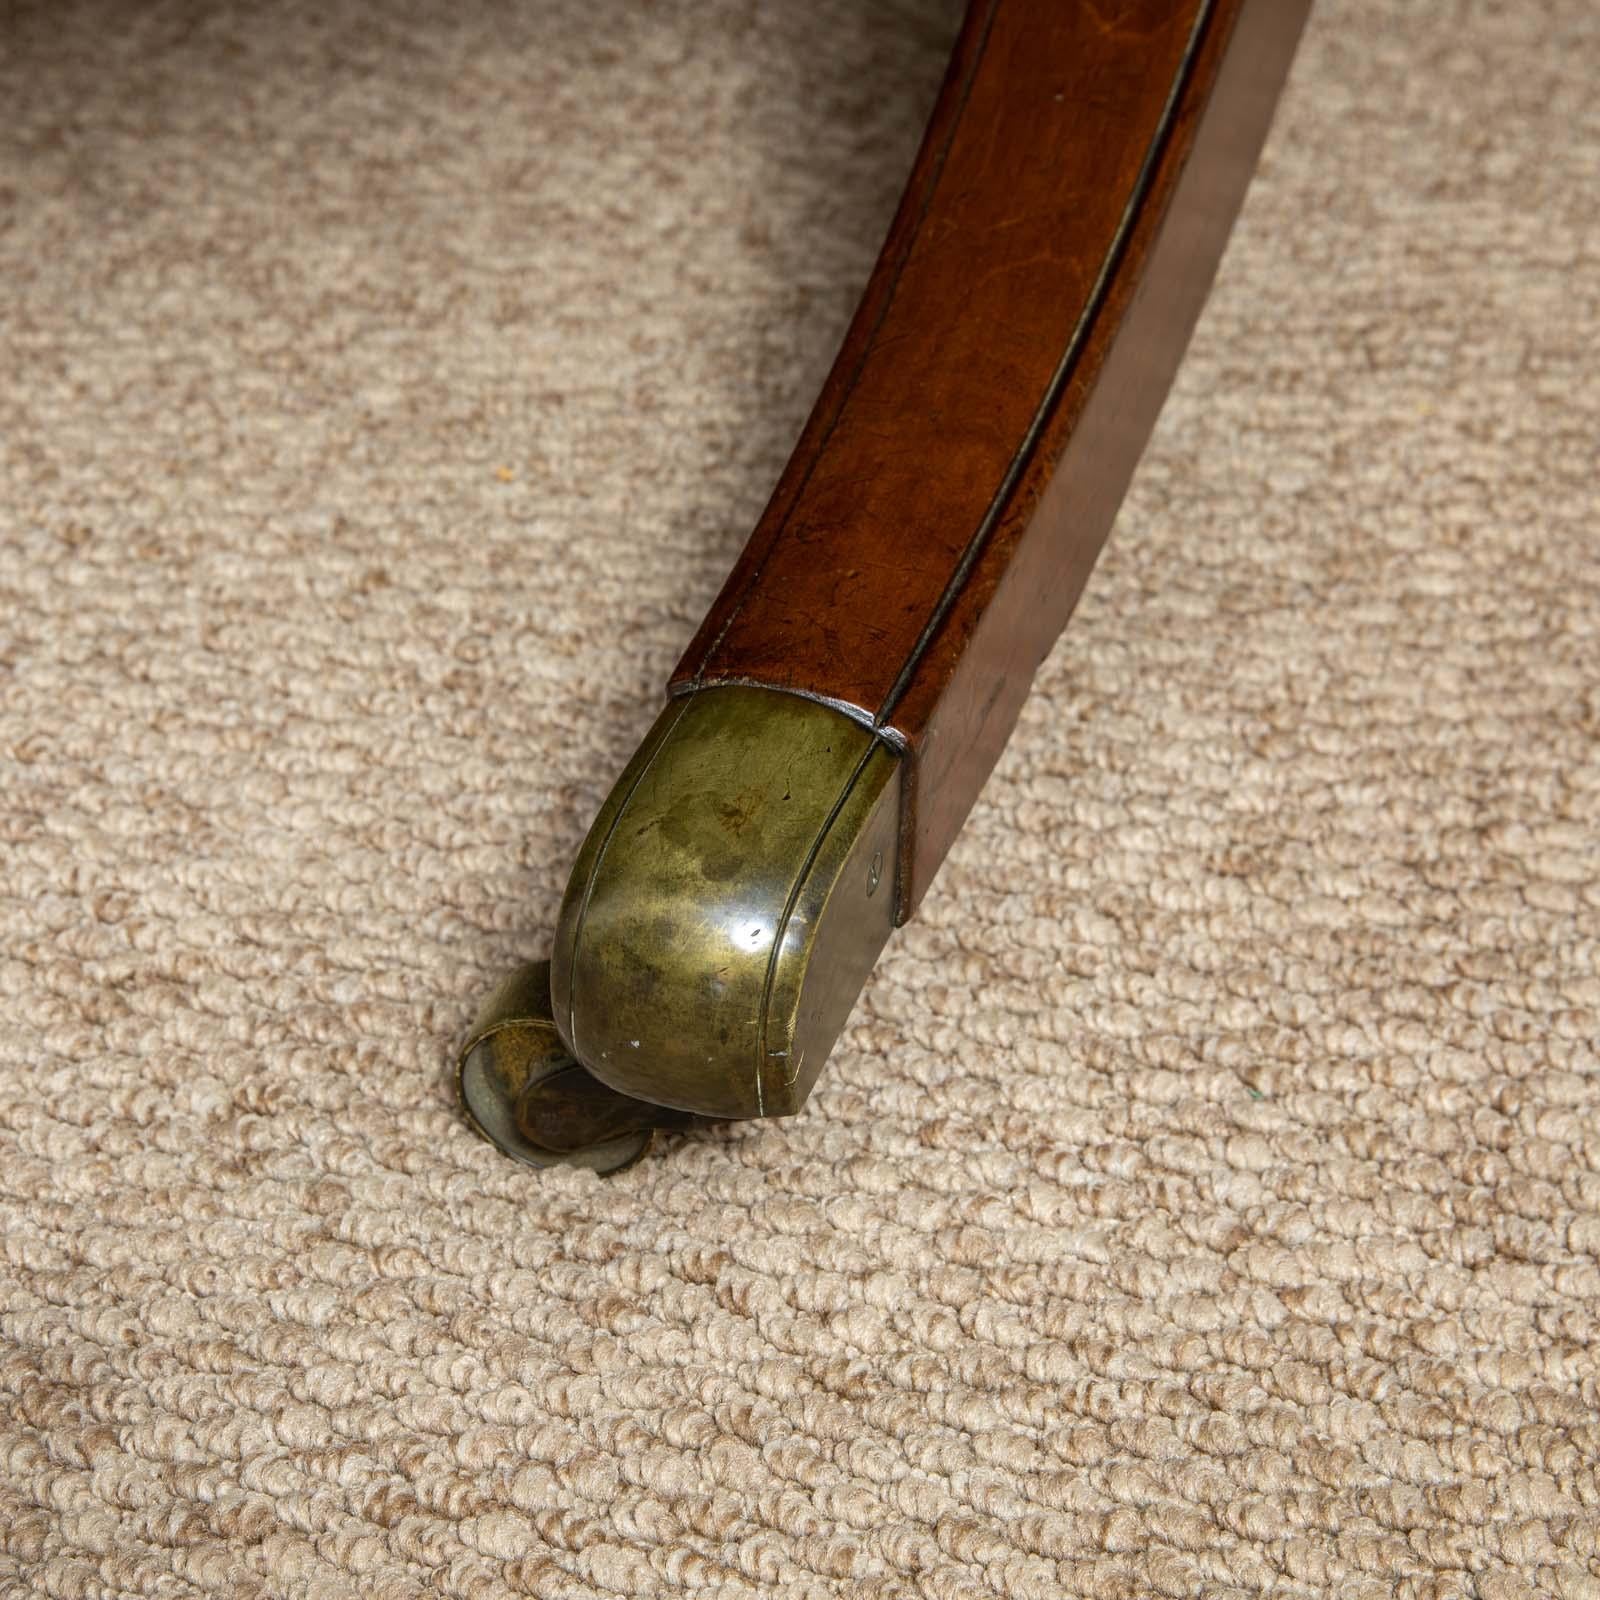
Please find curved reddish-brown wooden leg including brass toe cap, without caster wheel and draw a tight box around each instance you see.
[467,0,1309,1165]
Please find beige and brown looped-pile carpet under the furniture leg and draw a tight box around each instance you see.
[0,0,1600,1600]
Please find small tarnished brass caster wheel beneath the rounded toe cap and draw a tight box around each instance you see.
[456,962,698,1174]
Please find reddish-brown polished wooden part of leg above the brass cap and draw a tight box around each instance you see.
[672,0,1309,918]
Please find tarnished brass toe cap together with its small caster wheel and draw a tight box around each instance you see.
[461,685,901,1171]
